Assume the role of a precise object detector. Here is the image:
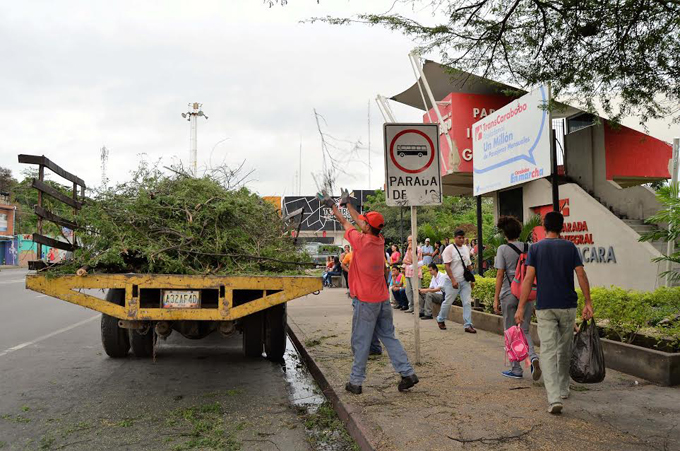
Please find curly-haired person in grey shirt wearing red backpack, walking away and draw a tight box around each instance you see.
[493,216,541,381]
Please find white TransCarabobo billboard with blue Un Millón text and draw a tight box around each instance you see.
[472,86,552,196]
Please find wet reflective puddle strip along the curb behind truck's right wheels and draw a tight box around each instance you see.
[283,338,326,413]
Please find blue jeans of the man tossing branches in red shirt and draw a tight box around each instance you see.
[349,299,415,385]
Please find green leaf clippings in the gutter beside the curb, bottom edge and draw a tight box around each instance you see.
[304,401,359,451]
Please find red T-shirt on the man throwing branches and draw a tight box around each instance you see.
[345,229,390,302]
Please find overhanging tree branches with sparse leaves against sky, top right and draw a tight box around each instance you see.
[318,0,680,123]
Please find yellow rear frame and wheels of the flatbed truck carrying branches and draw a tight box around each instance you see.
[26,273,322,361]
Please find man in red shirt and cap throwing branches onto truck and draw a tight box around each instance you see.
[319,190,418,395]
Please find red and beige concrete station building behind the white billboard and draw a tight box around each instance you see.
[391,61,672,291]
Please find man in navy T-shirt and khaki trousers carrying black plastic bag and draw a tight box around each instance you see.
[515,211,593,414]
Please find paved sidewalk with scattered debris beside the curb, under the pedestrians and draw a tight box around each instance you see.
[288,289,680,451]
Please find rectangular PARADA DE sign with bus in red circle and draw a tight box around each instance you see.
[383,123,442,206]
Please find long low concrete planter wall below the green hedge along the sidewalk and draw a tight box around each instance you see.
[432,305,680,386]
